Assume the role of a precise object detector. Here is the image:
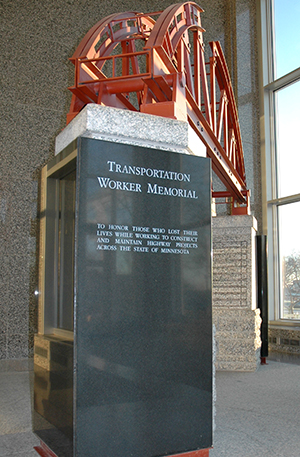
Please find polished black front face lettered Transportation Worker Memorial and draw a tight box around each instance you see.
[74,139,212,457]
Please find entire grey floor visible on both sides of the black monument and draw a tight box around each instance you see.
[0,356,300,457]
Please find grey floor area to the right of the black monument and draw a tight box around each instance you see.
[209,357,300,457]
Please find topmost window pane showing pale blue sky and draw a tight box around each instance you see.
[274,0,300,79]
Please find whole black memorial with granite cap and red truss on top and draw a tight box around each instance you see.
[34,2,249,457]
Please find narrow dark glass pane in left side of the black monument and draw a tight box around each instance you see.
[57,171,76,330]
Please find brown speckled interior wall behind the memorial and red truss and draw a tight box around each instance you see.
[0,0,261,359]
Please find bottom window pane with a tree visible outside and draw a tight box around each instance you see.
[278,202,300,319]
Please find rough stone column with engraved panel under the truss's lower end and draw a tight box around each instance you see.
[213,216,261,371]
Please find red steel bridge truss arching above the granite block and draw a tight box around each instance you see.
[67,2,250,214]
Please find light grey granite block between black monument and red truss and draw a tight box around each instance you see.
[55,104,206,157]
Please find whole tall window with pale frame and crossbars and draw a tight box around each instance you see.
[261,0,300,325]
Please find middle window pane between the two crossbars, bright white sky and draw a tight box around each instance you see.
[275,81,300,197]
